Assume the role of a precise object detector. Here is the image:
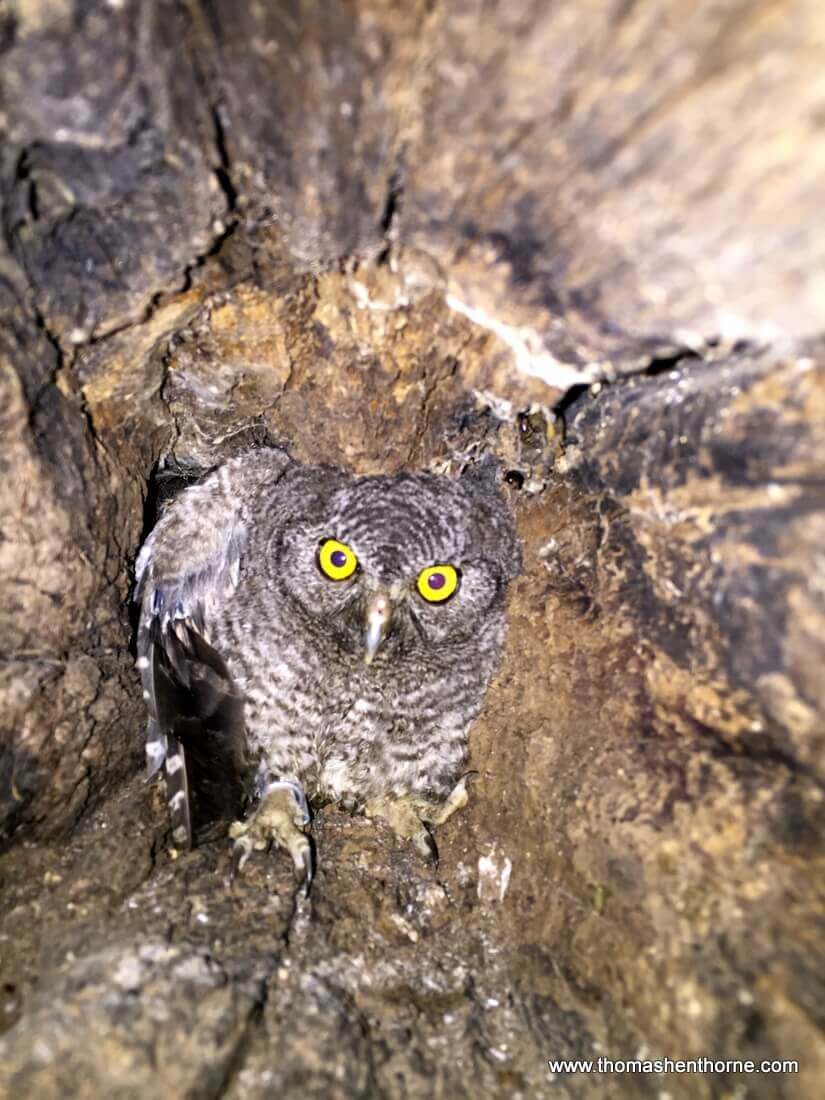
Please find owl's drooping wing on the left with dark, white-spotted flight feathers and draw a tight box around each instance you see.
[135,451,288,847]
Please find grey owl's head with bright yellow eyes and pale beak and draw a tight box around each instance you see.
[276,470,520,664]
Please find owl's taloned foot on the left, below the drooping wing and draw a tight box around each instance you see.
[229,779,312,892]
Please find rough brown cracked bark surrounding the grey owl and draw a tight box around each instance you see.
[0,0,825,1100]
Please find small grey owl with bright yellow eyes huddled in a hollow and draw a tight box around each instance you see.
[135,448,520,886]
